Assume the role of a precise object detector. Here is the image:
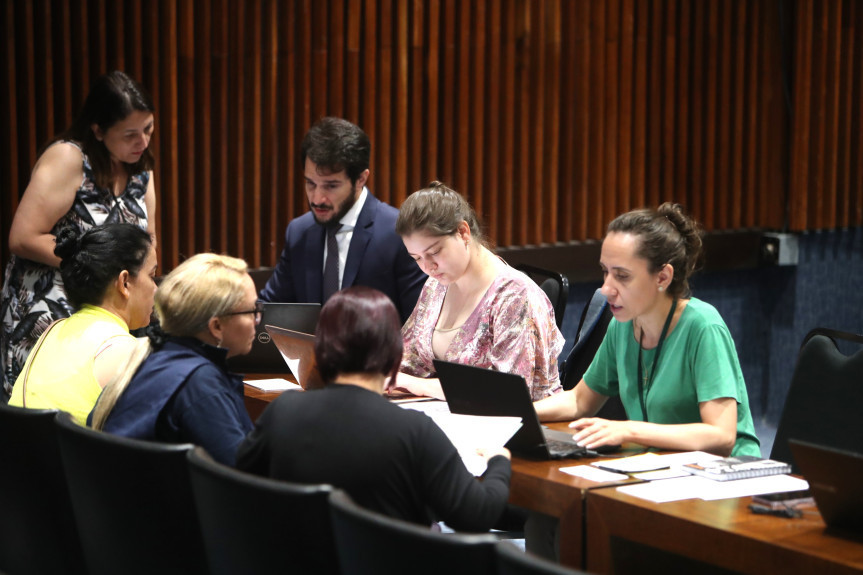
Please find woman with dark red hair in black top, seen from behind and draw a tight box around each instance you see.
[237,286,510,531]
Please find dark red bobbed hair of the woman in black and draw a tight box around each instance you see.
[315,286,404,383]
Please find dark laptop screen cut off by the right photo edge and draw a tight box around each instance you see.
[788,439,863,534]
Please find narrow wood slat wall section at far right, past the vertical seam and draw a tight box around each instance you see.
[789,0,863,230]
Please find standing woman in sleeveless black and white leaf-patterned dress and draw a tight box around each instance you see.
[0,72,156,400]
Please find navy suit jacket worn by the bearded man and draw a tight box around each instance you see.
[260,193,427,323]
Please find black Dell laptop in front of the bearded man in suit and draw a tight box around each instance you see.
[228,303,321,374]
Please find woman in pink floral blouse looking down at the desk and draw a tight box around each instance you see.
[396,182,563,401]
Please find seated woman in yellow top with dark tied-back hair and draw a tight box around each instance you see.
[9,224,156,425]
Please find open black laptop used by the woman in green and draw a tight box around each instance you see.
[434,359,588,459]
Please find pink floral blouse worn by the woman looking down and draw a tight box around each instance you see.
[400,267,564,401]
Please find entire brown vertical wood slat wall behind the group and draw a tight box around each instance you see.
[0,0,863,271]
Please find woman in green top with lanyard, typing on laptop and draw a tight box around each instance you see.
[535,203,761,456]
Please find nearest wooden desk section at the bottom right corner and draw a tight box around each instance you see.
[586,489,863,575]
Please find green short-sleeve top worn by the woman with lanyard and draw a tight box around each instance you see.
[584,298,761,456]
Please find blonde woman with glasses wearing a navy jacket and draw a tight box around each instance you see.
[91,254,261,465]
